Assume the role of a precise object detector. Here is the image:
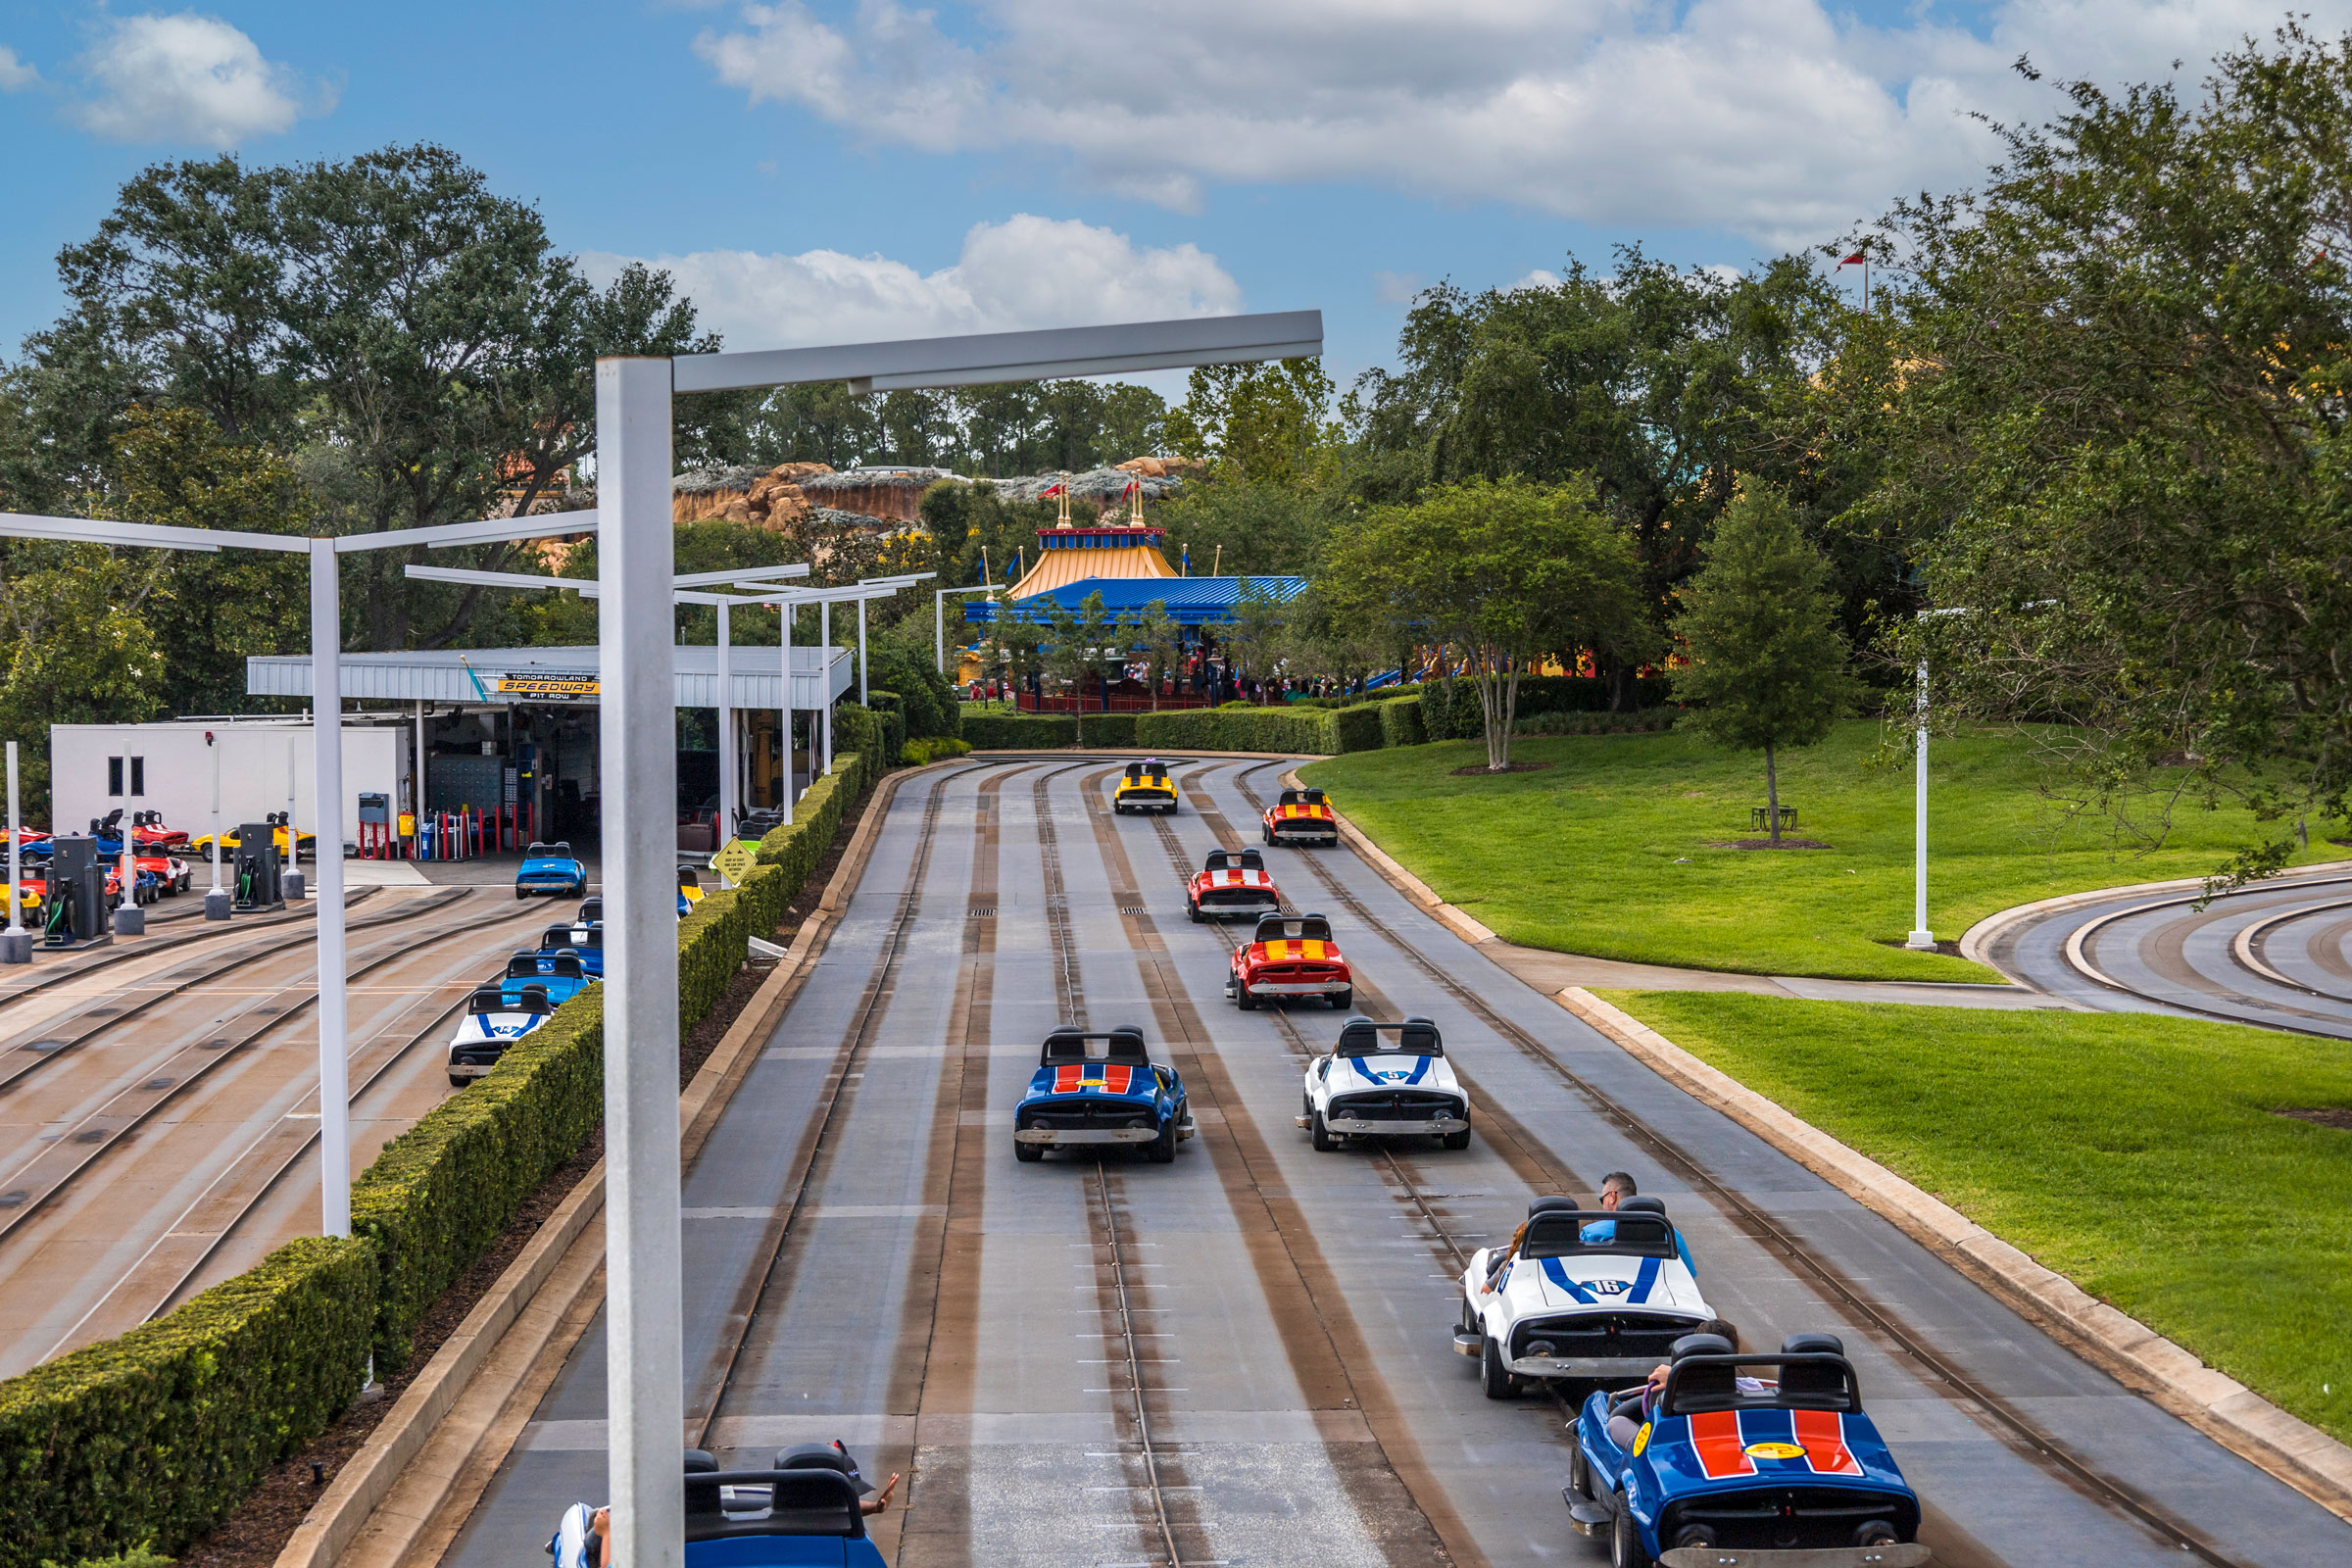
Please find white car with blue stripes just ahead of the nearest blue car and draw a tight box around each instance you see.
[1453,1197,1739,1398]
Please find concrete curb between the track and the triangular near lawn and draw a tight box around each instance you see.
[1554,985,2352,1521]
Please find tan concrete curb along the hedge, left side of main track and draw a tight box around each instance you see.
[275,760,936,1568]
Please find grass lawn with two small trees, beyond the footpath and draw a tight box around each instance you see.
[1303,721,2347,980]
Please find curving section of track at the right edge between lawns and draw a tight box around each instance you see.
[1985,867,2352,1039]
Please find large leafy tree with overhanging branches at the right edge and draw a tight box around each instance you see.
[1856,24,2352,877]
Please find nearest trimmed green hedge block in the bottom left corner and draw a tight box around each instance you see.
[0,1237,376,1568]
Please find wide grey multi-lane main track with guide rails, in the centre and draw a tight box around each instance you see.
[449,757,2352,1568]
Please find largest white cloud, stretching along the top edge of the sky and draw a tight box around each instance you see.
[694,0,2352,244]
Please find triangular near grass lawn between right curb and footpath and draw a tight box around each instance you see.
[1601,992,2352,1439]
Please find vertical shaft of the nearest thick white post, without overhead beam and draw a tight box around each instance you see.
[595,360,687,1568]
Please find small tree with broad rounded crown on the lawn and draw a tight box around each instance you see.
[1319,479,1642,768]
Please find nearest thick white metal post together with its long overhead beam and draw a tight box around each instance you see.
[595,311,1322,1568]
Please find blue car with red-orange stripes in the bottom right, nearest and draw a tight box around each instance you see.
[1564,1333,1929,1568]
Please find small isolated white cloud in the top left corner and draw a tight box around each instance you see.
[71,12,334,148]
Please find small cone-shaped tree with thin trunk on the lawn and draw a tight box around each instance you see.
[1675,484,1856,847]
